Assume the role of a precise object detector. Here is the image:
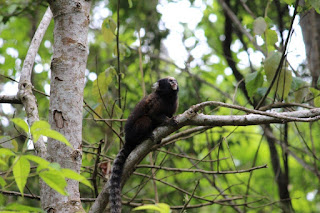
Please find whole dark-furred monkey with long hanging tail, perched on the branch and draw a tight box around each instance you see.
[109,77,179,213]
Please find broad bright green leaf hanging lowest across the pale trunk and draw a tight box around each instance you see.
[39,170,68,195]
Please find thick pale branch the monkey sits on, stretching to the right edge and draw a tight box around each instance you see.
[89,101,320,213]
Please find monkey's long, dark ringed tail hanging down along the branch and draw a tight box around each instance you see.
[109,143,134,213]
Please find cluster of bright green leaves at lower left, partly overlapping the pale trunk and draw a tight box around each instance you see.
[0,118,92,200]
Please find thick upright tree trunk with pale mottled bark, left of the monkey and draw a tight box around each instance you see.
[41,0,91,212]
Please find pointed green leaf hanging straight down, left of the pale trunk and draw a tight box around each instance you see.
[12,156,30,196]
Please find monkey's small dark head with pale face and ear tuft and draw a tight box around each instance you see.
[152,76,179,94]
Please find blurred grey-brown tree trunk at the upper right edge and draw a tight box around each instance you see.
[300,9,320,89]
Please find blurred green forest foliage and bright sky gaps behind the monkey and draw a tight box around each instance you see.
[0,0,320,212]
